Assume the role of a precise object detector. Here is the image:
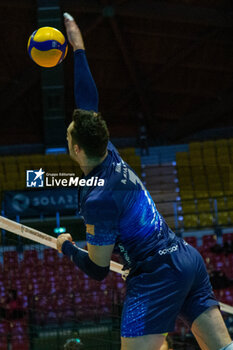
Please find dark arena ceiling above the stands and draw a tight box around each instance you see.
[0,0,233,144]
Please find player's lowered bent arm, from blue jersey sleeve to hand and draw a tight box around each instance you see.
[57,197,119,281]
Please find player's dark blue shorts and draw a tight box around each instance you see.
[121,238,219,338]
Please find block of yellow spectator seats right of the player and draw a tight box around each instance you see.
[176,139,233,229]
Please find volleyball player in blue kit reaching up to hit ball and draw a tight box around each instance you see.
[57,14,233,350]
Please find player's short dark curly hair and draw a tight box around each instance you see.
[70,109,109,158]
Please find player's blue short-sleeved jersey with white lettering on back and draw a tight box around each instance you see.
[80,143,174,268]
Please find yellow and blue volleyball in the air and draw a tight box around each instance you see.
[27,27,68,68]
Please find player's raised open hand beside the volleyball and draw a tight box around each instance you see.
[63,12,85,51]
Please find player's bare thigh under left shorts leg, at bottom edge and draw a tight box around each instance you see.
[121,334,165,350]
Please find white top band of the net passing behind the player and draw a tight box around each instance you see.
[0,216,233,314]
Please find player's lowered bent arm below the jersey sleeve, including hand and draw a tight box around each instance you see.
[57,234,114,281]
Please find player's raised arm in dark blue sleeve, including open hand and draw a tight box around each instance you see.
[64,12,99,112]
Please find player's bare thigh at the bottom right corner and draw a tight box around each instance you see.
[191,306,231,350]
